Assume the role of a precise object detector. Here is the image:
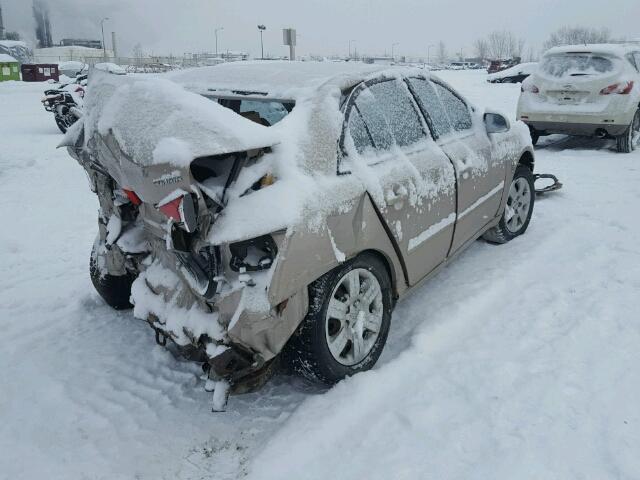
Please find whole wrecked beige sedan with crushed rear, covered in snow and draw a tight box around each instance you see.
[63,62,534,408]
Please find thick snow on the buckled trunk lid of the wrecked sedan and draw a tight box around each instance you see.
[84,71,278,168]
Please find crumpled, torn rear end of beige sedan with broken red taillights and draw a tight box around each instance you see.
[84,138,278,406]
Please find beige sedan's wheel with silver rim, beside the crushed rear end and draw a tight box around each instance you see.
[285,253,393,385]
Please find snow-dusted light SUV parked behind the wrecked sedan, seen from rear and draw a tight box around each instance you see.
[517,44,640,153]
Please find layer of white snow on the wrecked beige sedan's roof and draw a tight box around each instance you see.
[167,61,412,100]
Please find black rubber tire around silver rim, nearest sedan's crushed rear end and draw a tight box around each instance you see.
[283,253,393,385]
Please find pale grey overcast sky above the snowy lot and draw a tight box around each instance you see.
[0,0,640,56]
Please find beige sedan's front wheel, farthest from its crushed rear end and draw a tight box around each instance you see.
[483,165,535,243]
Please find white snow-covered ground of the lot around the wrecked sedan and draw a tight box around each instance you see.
[0,71,640,480]
